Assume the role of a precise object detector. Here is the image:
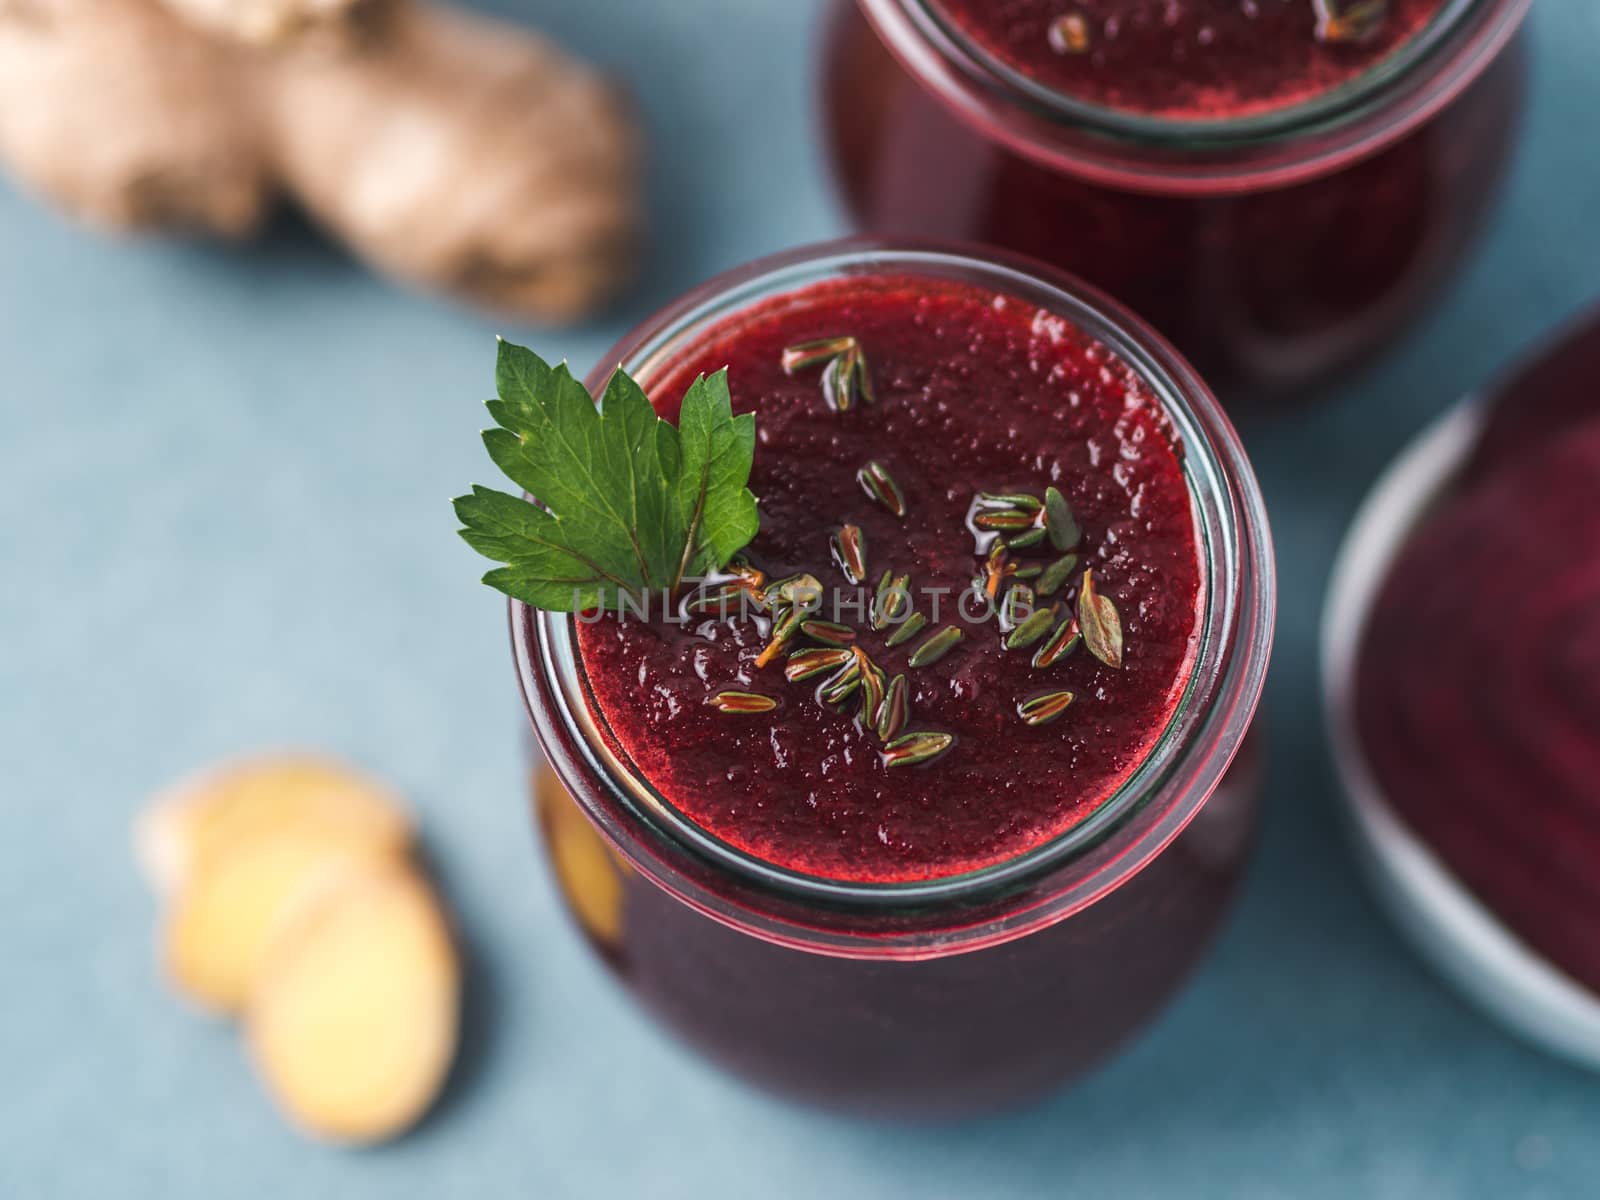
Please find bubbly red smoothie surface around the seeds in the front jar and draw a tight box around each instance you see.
[579,277,1202,882]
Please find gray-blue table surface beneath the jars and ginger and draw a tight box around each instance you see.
[0,0,1600,1200]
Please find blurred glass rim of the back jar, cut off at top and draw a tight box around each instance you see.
[859,0,1531,192]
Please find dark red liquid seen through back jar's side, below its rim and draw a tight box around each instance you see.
[822,0,1525,400]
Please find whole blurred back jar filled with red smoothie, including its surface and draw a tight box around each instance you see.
[821,0,1528,402]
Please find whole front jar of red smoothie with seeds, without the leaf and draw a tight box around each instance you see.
[512,243,1272,1115]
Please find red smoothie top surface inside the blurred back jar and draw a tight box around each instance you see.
[928,0,1445,120]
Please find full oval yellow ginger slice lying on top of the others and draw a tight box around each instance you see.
[245,861,461,1142]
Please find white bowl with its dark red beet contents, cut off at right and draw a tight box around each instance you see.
[1325,314,1600,1066]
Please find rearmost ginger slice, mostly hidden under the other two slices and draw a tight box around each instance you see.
[134,754,411,894]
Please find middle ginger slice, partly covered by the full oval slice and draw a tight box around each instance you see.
[163,830,392,1013]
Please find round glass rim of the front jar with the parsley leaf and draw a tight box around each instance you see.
[510,238,1275,957]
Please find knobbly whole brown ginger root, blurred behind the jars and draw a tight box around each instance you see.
[0,0,640,320]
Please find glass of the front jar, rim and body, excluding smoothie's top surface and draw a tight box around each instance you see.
[510,242,1274,1115]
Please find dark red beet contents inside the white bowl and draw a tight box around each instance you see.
[1357,325,1600,992]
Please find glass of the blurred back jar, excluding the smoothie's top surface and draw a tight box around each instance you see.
[822,0,1528,403]
